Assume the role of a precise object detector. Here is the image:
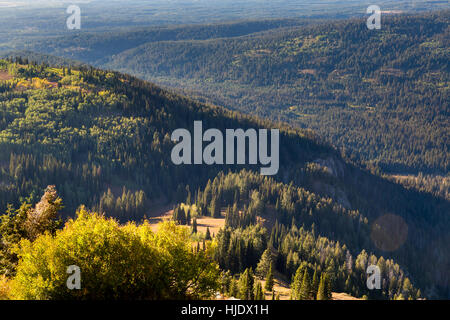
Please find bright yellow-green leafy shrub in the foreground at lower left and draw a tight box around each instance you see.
[11,209,219,299]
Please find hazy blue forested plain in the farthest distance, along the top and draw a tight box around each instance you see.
[0,0,448,53]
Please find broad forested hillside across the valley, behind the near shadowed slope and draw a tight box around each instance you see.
[31,11,444,175]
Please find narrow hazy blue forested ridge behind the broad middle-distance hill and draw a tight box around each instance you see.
[23,19,308,65]
